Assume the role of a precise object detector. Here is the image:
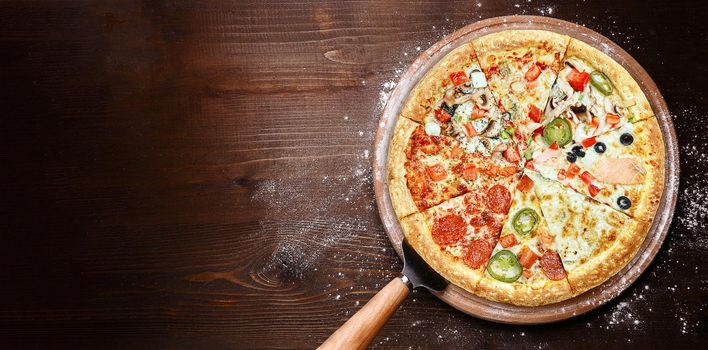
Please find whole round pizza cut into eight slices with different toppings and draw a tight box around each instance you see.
[387,30,664,306]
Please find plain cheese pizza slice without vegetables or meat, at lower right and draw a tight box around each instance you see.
[526,171,651,295]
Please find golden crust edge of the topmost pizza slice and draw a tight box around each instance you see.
[472,29,570,71]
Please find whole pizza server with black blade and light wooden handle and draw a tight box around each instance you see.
[319,240,448,350]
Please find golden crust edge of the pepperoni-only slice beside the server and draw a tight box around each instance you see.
[401,213,483,293]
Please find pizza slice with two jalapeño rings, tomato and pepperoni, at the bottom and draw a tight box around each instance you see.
[475,175,572,306]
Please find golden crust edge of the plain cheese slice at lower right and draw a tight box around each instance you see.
[568,212,648,295]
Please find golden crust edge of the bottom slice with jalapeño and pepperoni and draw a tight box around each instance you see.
[474,275,573,306]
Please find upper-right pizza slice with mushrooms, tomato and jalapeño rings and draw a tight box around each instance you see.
[538,39,653,147]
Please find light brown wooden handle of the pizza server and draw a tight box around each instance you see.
[319,278,410,350]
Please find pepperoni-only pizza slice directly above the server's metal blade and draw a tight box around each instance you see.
[401,175,518,292]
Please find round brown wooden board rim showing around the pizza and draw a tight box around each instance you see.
[373,16,679,324]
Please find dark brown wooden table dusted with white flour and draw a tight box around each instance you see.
[0,0,708,349]
